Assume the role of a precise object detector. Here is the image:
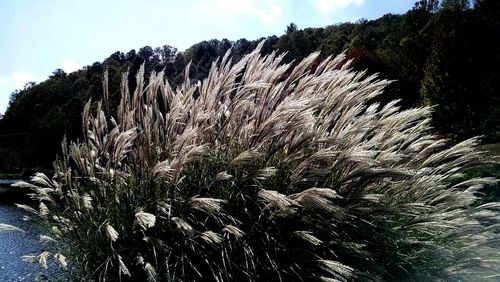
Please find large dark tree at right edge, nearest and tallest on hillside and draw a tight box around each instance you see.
[421,9,500,141]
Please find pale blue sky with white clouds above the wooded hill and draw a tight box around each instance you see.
[0,0,416,113]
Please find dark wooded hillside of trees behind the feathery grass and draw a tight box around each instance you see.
[0,0,500,174]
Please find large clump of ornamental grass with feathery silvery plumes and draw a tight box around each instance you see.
[6,43,500,281]
